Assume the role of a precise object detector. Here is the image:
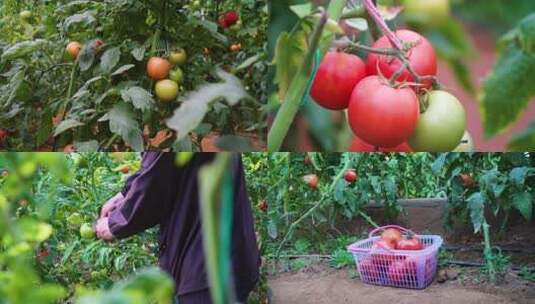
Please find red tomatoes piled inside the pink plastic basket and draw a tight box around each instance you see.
[359,228,430,285]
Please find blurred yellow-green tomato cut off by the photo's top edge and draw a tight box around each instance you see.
[403,0,451,26]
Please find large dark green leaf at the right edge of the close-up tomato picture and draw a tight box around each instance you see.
[480,46,535,137]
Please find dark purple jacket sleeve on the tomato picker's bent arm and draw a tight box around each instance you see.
[109,152,179,238]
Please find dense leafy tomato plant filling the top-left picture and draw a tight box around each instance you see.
[0,0,267,151]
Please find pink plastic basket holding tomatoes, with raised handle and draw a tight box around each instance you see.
[347,225,442,289]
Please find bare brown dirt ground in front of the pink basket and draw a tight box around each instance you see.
[268,263,535,304]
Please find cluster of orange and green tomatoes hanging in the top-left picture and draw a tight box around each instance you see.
[147,48,187,102]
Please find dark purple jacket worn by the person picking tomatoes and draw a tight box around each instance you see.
[109,152,260,295]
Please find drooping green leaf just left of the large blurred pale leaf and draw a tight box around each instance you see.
[99,102,143,151]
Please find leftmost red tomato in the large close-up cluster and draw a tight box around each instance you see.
[310,52,366,110]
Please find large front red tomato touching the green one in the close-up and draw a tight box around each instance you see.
[348,76,420,148]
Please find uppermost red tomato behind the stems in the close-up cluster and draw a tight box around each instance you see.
[367,29,437,88]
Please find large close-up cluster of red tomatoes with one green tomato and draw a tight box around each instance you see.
[310,30,466,152]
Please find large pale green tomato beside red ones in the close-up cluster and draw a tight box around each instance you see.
[409,91,466,152]
